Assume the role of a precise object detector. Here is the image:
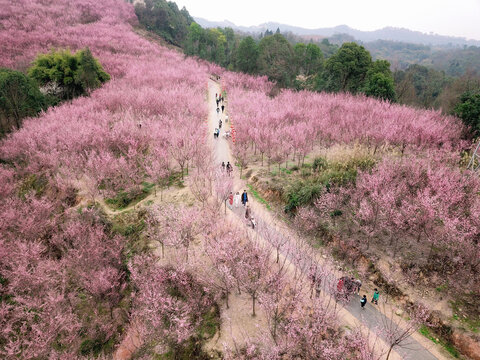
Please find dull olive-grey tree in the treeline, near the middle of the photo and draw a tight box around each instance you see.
[257,34,296,86]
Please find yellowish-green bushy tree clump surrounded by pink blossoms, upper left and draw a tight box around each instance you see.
[28,48,110,100]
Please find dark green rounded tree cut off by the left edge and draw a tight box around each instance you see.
[0,68,46,138]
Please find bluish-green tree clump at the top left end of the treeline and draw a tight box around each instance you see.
[135,0,193,46]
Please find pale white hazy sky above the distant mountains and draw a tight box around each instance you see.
[174,0,480,40]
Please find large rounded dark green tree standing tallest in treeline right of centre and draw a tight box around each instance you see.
[325,42,372,94]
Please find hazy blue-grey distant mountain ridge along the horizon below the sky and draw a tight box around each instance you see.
[194,17,480,46]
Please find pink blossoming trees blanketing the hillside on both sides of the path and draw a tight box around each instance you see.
[0,0,478,360]
